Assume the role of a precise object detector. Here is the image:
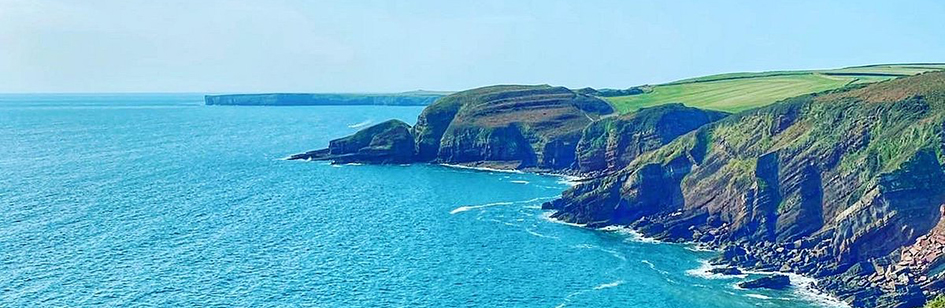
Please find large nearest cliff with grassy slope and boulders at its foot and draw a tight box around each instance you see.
[545,73,945,307]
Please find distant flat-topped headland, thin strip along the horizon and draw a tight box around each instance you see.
[204,91,445,106]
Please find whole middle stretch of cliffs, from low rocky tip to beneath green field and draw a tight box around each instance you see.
[292,85,726,174]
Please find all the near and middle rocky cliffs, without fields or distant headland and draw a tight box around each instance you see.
[292,73,945,308]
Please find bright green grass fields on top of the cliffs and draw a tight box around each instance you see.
[604,64,945,113]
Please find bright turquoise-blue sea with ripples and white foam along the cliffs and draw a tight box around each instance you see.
[0,94,835,308]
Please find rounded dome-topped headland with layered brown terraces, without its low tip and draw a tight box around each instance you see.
[428,86,613,169]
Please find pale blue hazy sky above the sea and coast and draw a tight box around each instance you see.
[0,0,945,93]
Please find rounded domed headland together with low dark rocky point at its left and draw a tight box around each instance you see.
[293,85,613,170]
